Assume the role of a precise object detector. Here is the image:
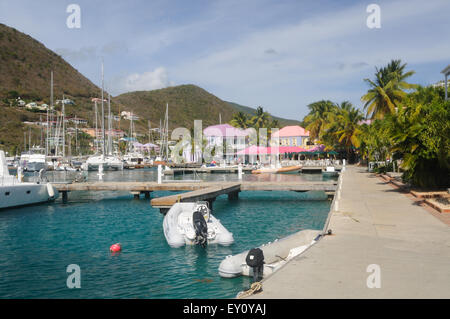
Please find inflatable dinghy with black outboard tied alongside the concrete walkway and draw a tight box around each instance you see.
[219,229,321,278]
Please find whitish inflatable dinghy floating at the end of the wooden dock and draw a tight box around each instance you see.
[163,202,234,248]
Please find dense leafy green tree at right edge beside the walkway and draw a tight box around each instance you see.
[389,88,450,187]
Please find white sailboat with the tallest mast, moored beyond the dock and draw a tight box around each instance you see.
[83,62,123,171]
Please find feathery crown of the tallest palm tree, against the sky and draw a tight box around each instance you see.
[361,60,415,119]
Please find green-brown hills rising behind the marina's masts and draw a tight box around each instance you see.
[0,24,298,154]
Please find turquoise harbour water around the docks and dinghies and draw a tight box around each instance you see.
[0,170,330,298]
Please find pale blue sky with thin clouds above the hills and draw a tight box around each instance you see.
[0,0,450,120]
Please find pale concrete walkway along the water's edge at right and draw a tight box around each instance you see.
[252,166,450,299]
